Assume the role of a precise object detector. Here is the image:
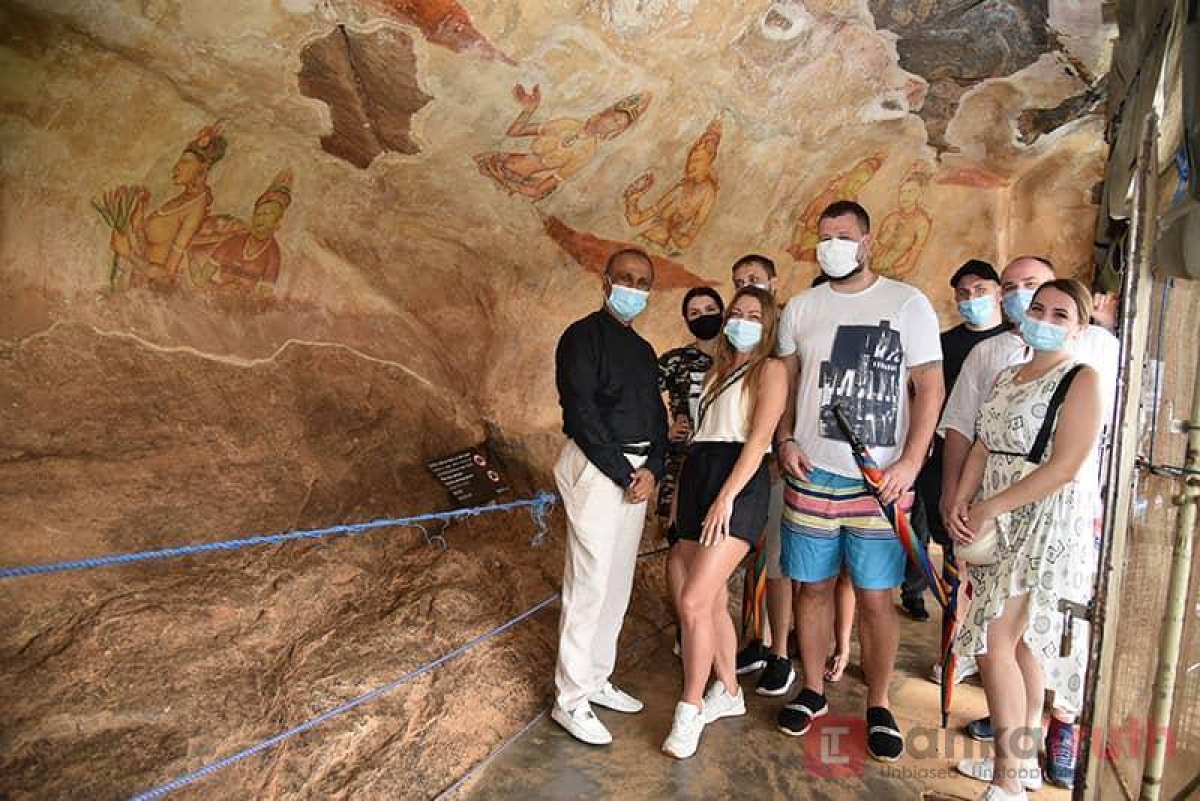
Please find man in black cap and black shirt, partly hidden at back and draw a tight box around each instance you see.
[900,259,1004,623]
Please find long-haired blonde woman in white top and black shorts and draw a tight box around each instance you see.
[662,287,787,759]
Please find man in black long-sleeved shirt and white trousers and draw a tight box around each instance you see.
[551,248,667,745]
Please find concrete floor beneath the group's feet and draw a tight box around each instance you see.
[462,599,1069,801]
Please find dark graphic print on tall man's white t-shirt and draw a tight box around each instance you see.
[820,320,904,447]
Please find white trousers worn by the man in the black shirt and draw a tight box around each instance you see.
[554,440,646,711]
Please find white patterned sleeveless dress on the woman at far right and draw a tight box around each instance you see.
[954,360,1098,711]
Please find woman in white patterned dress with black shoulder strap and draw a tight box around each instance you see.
[950,278,1100,801]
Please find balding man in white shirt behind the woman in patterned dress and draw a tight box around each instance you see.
[937,255,1120,787]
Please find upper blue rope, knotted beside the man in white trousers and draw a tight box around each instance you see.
[0,492,558,579]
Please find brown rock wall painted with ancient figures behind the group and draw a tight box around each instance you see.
[0,0,1110,797]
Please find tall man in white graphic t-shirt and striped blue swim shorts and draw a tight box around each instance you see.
[775,200,944,761]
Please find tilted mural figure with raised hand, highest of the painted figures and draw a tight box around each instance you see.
[475,84,650,200]
